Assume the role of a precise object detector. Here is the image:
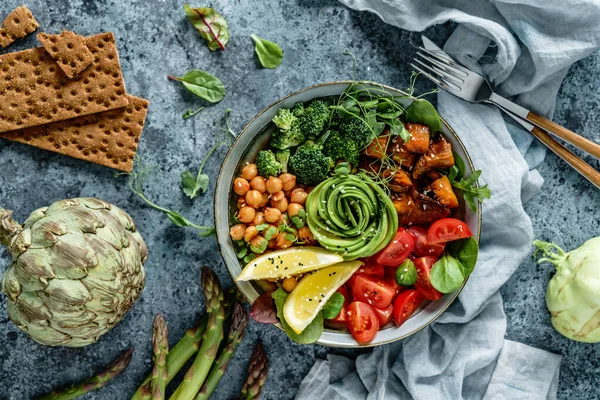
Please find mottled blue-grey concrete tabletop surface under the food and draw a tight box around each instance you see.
[0,0,600,400]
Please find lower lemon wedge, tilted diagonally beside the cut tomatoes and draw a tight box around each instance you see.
[283,260,362,334]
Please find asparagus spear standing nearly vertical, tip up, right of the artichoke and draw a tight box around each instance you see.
[151,313,169,400]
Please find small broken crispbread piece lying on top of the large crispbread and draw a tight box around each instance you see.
[37,31,94,79]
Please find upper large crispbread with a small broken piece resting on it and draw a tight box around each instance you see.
[0,32,129,132]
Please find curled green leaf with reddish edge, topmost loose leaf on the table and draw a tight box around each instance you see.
[183,4,229,51]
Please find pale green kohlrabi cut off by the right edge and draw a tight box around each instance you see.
[533,237,600,343]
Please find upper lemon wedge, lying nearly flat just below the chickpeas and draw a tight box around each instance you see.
[236,246,344,281]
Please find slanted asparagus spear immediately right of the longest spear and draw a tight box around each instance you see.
[196,303,248,400]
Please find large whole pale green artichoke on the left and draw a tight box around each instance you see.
[0,198,148,347]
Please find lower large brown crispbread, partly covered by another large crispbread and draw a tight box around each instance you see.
[0,96,149,172]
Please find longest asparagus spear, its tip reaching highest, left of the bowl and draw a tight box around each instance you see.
[170,267,225,400]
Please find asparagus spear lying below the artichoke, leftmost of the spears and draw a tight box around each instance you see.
[39,349,133,400]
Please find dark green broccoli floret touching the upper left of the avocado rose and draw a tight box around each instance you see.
[289,141,333,186]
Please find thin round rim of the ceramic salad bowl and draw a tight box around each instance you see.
[213,80,482,348]
